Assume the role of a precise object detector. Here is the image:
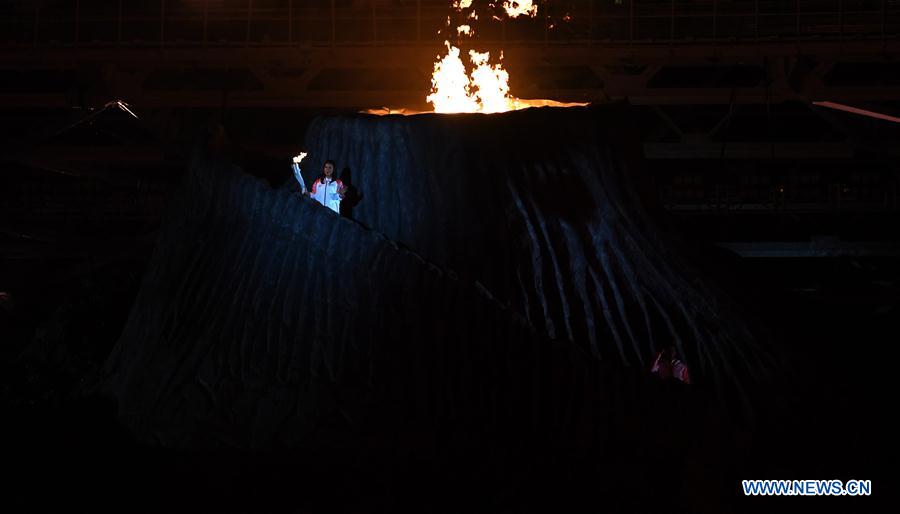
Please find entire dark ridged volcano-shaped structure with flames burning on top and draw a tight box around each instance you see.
[107,107,766,447]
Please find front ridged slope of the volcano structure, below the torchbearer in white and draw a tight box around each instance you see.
[107,149,684,447]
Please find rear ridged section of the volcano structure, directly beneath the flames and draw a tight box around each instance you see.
[306,106,771,388]
